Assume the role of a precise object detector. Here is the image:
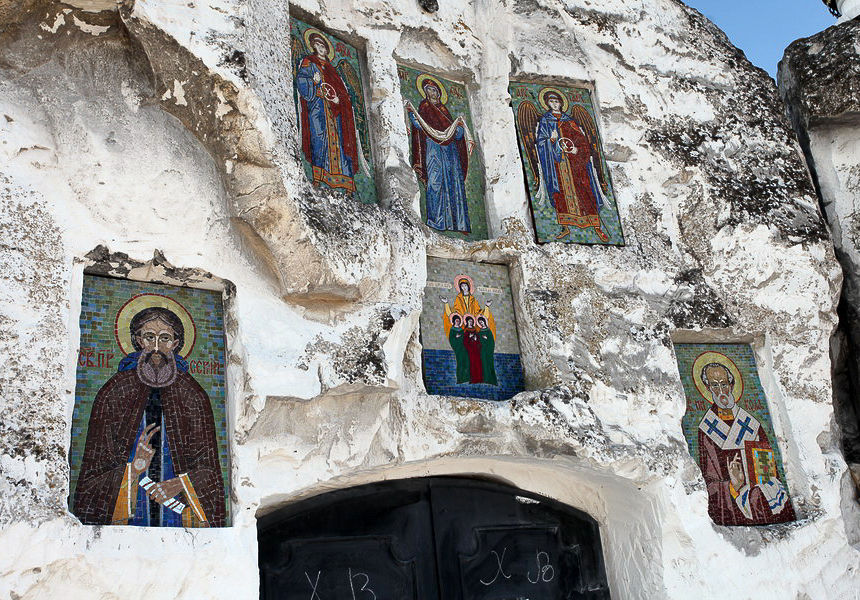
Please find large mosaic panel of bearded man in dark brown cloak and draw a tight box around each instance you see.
[69,275,229,527]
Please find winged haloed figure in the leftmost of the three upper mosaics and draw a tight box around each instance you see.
[292,28,370,192]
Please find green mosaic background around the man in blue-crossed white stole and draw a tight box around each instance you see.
[675,344,788,491]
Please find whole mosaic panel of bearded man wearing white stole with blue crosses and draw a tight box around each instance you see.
[675,344,796,525]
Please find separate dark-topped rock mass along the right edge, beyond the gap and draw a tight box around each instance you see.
[779,19,860,512]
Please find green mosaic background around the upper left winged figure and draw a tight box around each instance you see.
[290,19,377,204]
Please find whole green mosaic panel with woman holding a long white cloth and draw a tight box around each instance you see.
[397,65,488,240]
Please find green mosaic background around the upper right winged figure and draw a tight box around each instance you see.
[508,82,624,246]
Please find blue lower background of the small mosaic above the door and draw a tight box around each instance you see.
[423,348,525,400]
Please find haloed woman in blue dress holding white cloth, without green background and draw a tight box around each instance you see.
[406,73,475,234]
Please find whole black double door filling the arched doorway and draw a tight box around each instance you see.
[258,477,609,600]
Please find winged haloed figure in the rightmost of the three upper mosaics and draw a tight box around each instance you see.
[517,87,609,242]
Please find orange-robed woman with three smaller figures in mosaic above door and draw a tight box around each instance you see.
[441,275,498,385]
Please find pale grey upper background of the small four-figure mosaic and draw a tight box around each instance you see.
[421,258,520,354]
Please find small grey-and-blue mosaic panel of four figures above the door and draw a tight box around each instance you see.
[421,258,524,400]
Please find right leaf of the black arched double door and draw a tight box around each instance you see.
[430,479,609,600]
